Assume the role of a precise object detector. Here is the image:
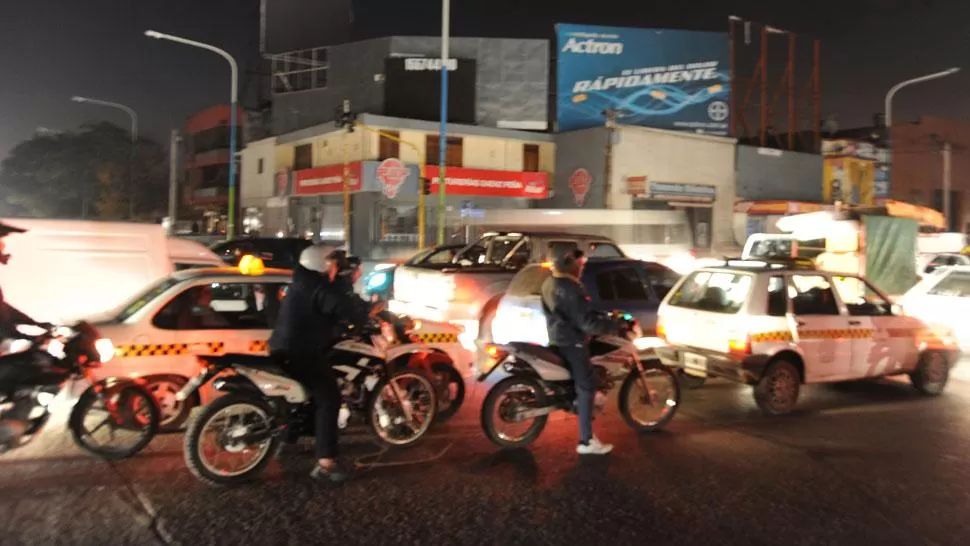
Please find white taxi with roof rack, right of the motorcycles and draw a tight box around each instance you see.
[657,260,960,415]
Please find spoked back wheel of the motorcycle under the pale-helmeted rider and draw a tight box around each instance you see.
[185,394,280,486]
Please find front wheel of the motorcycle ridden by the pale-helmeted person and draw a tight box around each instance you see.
[367,370,438,446]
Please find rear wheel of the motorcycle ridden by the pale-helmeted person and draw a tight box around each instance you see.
[185,394,281,486]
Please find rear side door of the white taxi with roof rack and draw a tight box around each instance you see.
[788,273,852,383]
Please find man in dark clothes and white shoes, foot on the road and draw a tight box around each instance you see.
[541,250,620,455]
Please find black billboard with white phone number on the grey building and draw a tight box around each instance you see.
[384,57,476,125]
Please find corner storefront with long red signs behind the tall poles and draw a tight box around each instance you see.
[274,158,549,259]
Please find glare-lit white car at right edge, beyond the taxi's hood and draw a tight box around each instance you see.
[896,265,970,352]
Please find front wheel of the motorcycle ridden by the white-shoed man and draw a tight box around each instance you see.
[617,361,680,432]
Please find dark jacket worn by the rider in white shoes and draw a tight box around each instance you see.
[542,276,620,347]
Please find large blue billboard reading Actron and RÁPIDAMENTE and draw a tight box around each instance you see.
[556,24,731,135]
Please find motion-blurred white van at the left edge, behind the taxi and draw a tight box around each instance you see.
[0,218,222,323]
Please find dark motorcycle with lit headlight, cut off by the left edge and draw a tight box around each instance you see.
[0,322,161,460]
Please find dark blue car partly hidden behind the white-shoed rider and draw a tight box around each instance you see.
[488,258,680,348]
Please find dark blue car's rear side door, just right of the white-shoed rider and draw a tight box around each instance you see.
[590,262,660,333]
